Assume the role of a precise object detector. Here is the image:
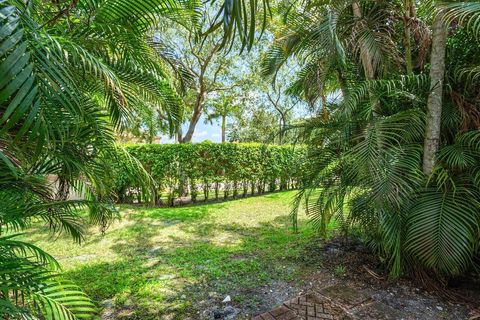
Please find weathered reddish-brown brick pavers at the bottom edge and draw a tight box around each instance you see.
[253,292,349,320]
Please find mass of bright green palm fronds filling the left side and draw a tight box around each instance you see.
[0,0,266,319]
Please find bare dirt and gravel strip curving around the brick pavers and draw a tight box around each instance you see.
[199,239,480,320]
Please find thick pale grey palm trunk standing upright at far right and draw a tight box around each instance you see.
[423,12,447,175]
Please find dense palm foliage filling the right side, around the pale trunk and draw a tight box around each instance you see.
[265,1,480,280]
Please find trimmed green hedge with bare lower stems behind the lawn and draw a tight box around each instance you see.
[116,143,305,205]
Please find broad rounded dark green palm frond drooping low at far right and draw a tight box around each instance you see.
[405,188,479,274]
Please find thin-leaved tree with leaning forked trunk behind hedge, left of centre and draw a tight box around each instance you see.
[155,4,246,143]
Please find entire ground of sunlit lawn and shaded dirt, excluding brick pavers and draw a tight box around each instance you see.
[25,191,480,320]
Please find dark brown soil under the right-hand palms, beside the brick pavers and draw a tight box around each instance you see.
[298,238,480,319]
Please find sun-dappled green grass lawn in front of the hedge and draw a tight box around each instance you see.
[24,191,319,319]
